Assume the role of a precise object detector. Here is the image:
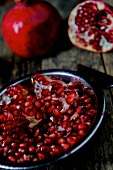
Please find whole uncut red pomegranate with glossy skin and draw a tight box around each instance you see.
[2,0,62,58]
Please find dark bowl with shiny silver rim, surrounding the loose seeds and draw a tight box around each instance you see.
[0,69,105,170]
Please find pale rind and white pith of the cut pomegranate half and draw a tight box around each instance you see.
[68,0,113,52]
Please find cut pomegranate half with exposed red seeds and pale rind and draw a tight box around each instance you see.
[68,0,113,52]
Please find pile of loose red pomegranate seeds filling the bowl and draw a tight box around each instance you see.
[0,74,98,163]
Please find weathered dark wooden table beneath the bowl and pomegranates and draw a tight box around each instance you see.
[0,0,113,170]
